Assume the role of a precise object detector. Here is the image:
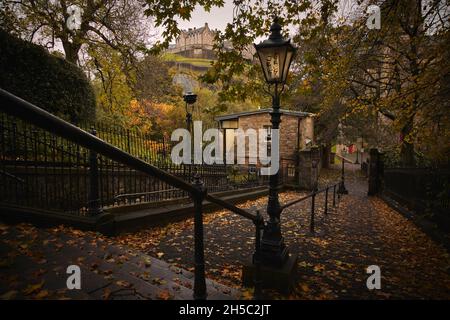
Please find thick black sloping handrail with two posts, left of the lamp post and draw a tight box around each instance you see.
[0,88,264,299]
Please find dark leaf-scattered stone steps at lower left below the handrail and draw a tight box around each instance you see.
[0,226,240,300]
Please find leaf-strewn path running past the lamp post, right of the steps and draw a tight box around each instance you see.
[117,171,450,299]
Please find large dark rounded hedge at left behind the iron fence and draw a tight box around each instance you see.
[0,30,95,123]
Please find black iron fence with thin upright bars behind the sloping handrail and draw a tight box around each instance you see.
[0,111,267,215]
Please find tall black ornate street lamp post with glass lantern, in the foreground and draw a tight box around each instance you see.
[255,18,296,267]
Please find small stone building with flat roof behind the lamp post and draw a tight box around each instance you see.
[215,109,314,165]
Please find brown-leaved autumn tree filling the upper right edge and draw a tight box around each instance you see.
[340,0,450,166]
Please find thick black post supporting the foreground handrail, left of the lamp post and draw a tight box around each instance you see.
[192,174,207,300]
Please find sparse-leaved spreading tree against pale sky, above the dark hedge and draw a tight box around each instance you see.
[0,0,151,64]
